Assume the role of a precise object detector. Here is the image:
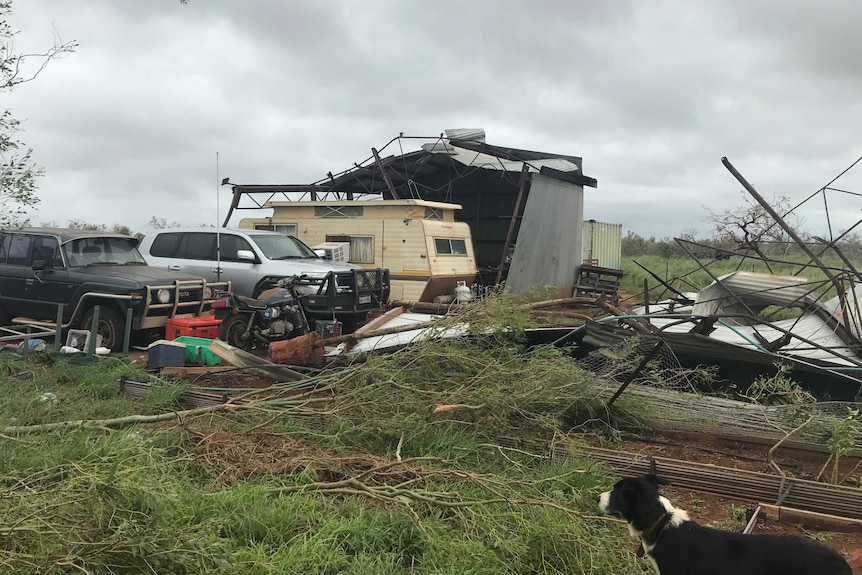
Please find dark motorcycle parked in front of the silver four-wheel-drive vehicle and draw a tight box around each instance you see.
[212,276,310,351]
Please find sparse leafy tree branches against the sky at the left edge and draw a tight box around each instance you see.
[0,0,78,226]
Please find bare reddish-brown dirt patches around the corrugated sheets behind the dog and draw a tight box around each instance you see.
[615,434,862,575]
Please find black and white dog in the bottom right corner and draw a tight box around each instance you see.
[598,475,851,575]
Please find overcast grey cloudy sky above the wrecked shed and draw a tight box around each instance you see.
[10,0,862,241]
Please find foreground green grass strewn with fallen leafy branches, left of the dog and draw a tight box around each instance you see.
[0,318,645,575]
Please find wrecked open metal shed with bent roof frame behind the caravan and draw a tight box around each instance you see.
[223,129,598,295]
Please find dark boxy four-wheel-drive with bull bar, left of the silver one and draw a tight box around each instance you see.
[0,228,230,351]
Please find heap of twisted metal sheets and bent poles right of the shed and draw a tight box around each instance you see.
[576,158,862,400]
